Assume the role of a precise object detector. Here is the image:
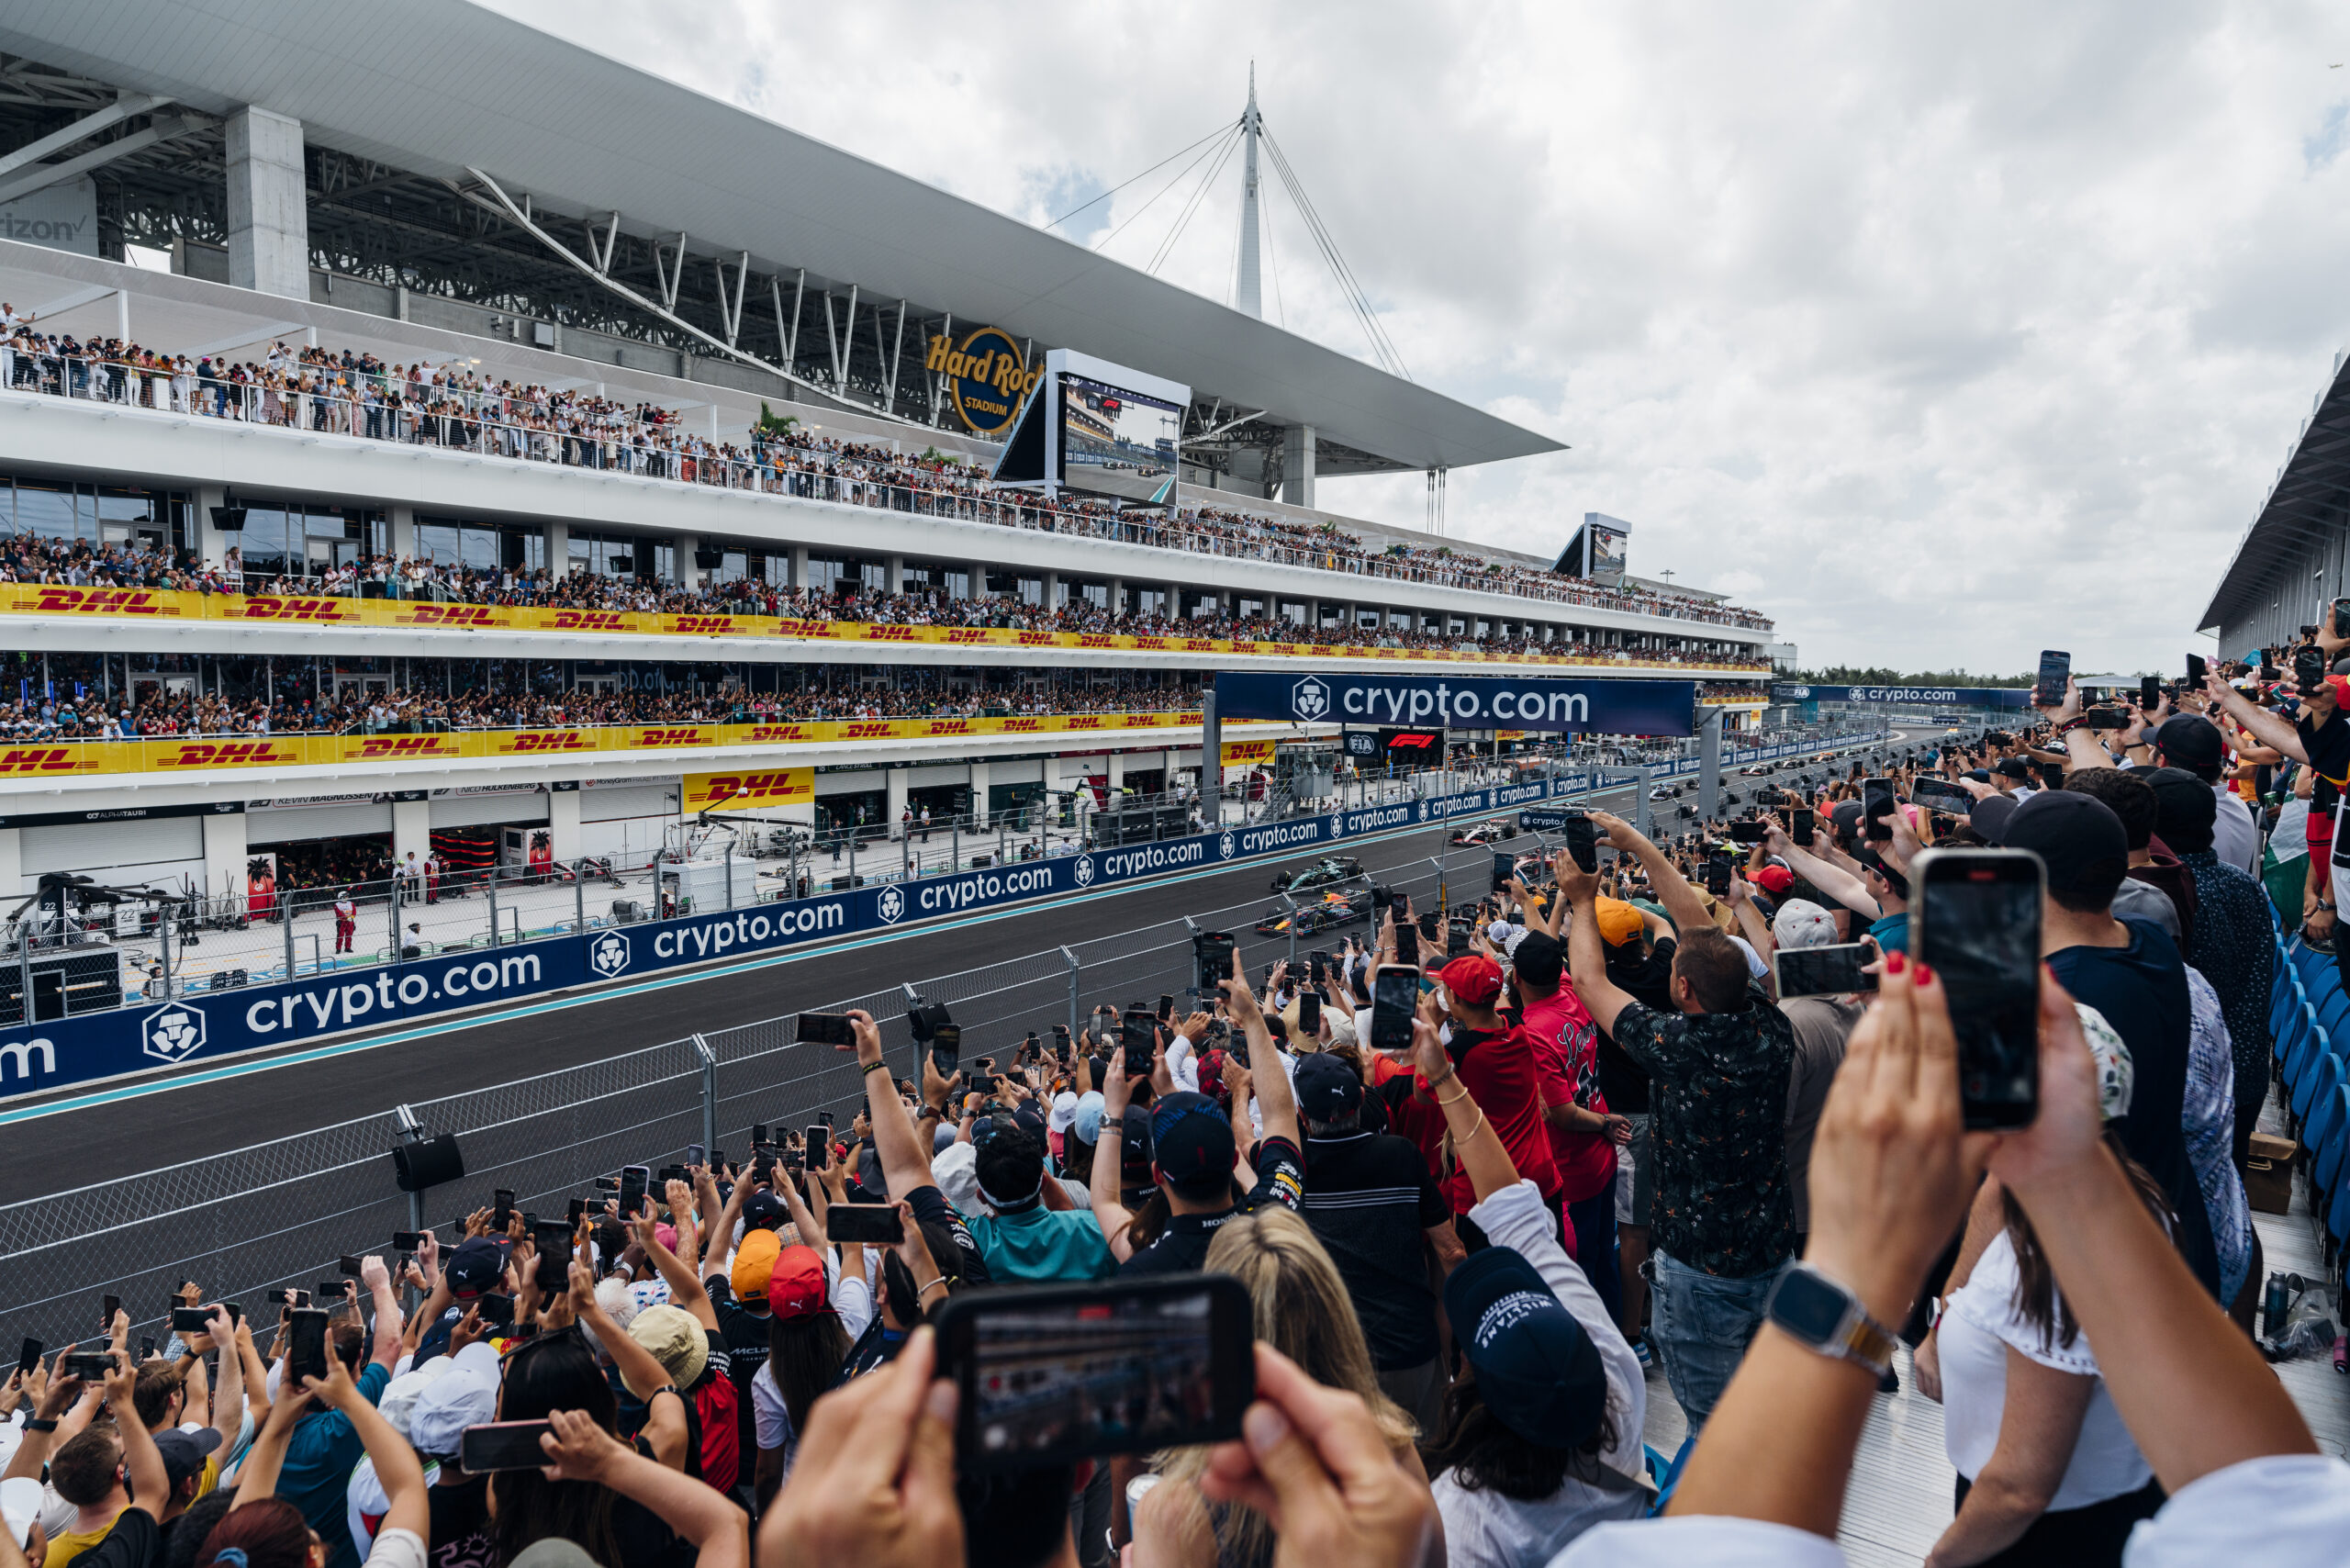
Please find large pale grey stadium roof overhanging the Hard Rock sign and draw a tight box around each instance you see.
[0,0,1561,479]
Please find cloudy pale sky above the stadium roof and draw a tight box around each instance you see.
[494,0,2350,672]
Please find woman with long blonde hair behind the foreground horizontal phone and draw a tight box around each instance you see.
[1135,1204,1427,1568]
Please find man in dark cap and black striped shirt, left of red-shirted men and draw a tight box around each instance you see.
[1295,1056,1466,1431]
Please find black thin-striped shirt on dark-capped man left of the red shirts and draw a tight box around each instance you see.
[1302,1128,1452,1372]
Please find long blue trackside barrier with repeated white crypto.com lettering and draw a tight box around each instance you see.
[0,747,1880,1098]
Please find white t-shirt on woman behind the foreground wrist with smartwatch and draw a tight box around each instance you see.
[1936,1229,2155,1512]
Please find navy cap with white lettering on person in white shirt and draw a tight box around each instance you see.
[1445,1246,1607,1448]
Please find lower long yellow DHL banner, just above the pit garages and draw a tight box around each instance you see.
[0,712,1271,780]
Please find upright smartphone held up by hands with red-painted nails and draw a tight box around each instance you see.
[1910,848,2044,1126]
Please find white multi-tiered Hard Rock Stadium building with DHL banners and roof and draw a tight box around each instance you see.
[0,0,1774,921]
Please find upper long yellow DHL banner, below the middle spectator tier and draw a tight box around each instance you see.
[0,583,1767,675]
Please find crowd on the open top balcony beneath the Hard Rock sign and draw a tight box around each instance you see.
[0,315,1770,630]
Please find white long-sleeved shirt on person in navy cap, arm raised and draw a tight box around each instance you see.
[1431,1180,1648,1568]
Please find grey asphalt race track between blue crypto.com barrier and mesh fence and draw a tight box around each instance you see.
[0,736,1904,1196]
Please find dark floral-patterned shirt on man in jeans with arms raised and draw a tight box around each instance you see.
[1615,999,1796,1279]
